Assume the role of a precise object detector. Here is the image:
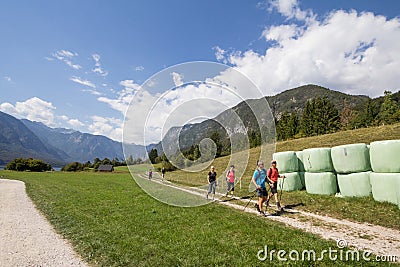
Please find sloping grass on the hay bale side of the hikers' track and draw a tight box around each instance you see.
[157,123,400,230]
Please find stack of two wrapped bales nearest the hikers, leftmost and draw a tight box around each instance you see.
[273,151,303,191]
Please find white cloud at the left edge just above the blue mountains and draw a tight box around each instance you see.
[0,97,56,126]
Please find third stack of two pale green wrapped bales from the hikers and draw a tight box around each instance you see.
[331,144,371,197]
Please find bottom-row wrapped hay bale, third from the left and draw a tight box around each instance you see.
[337,172,371,197]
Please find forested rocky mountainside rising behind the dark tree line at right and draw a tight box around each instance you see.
[155,85,370,154]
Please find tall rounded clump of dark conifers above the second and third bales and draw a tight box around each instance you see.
[301,97,340,136]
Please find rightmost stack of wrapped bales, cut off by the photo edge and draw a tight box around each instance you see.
[370,140,400,207]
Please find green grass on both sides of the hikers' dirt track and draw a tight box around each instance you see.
[0,124,400,266]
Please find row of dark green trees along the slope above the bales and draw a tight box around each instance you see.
[275,91,400,140]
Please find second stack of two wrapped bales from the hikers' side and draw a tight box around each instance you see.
[301,148,337,195]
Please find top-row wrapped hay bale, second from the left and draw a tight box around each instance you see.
[302,147,334,172]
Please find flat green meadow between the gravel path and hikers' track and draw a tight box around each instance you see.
[0,170,394,266]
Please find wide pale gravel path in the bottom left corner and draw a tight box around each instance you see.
[0,179,87,267]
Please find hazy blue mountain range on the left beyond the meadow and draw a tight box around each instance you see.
[0,112,146,166]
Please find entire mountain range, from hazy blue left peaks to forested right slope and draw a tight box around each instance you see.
[0,85,390,165]
